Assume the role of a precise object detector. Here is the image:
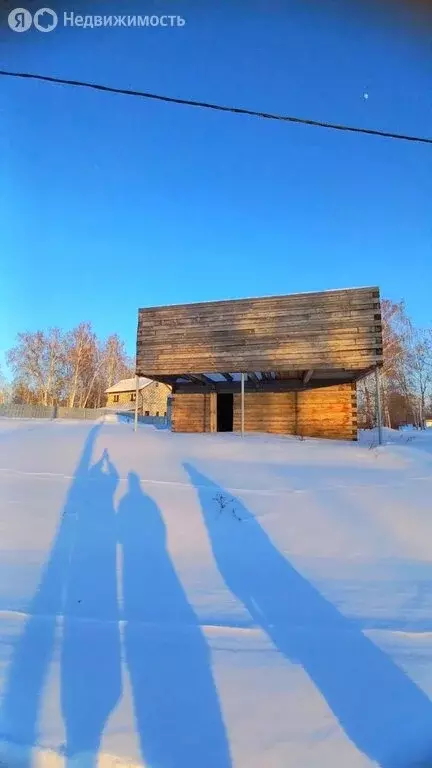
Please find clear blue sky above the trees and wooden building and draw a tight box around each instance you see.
[0,0,432,372]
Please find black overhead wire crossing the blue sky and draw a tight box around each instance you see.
[0,70,432,144]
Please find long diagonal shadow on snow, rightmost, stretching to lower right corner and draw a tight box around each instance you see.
[184,464,432,768]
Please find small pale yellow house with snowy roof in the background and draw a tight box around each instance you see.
[105,376,171,416]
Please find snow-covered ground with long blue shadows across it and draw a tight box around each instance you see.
[0,420,432,768]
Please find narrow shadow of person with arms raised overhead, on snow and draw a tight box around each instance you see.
[61,451,122,766]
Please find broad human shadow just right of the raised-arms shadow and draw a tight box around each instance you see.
[118,473,231,768]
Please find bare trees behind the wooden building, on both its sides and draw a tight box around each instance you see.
[0,299,432,428]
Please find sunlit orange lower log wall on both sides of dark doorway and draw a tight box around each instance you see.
[172,384,357,440]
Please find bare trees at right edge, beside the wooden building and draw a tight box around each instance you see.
[358,299,432,428]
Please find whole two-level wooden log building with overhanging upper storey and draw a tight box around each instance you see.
[137,288,382,439]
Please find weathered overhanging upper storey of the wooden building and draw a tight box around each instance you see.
[137,288,382,378]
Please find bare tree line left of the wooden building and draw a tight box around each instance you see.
[3,323,135,408]
